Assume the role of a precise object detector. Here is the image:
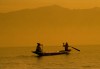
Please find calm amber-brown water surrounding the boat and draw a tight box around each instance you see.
[0,46,100,69]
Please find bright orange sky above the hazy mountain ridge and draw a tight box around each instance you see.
[0,0,100,12]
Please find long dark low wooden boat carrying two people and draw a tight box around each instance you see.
[32,50,71,56]
